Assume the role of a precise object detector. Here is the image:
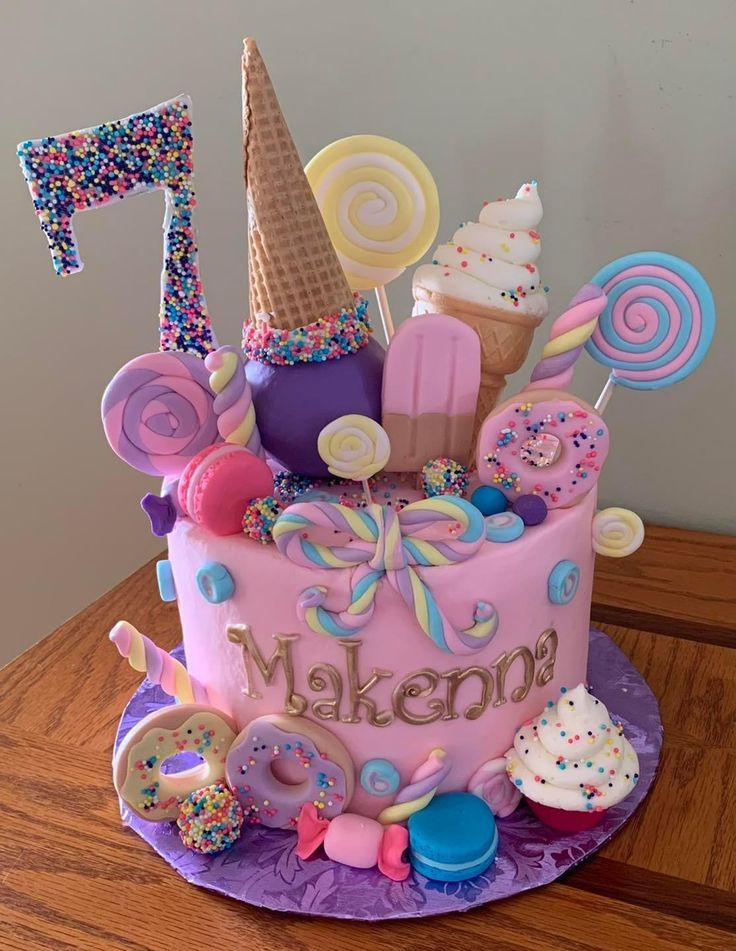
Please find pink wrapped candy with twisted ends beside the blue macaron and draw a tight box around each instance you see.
[296,802,410,882]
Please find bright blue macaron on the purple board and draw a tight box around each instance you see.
[409,792,498,882]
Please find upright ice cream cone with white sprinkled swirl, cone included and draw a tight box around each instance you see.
[412,182,547,443]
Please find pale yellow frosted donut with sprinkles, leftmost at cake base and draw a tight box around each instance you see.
[113,703,237,822]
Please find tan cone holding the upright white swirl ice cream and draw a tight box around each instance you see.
[413,284,544,447]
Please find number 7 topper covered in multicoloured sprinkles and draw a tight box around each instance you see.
[18,96,216,356]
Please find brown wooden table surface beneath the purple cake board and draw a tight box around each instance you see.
[0,526,736,951]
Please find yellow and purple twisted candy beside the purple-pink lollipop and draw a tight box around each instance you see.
[204,347,262,455]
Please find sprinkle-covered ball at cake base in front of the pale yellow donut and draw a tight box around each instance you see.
[176,783,243,855]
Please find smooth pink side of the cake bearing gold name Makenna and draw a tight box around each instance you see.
[164,492,595,817]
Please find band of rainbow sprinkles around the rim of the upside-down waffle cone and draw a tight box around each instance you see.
[243,296,373,366]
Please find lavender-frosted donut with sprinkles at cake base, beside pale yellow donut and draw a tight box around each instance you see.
[225,714,355,829]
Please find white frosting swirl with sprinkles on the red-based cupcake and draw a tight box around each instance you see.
[506,684,639,812]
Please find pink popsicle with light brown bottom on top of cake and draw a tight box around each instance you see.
[383,314,480,472]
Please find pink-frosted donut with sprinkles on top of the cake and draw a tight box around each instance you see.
[477,390,610,509]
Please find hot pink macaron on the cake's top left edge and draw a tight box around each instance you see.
[179,443,273,535]
